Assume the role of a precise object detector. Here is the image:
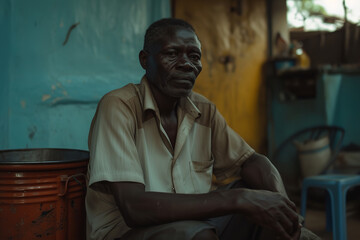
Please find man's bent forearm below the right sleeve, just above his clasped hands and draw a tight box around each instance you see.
[240,153,287,196]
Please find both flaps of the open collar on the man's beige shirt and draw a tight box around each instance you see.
[141,76,201,119]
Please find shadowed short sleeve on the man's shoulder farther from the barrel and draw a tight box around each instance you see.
[211,108,255,181]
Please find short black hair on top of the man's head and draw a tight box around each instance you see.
[143,18,196,50]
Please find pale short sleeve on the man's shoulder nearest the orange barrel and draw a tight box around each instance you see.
[89,96,144,187]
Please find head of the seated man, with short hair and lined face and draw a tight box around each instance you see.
[139,18,202,98]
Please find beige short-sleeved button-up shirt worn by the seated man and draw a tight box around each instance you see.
[86,77,254,240]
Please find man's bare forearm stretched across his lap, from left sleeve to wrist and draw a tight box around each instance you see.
[111,183,246,227]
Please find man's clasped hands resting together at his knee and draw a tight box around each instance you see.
[239,189,300,240]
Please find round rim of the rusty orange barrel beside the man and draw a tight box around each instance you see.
[0,148,90,165]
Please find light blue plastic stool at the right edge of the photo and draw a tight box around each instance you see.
[300,174,360,240]
